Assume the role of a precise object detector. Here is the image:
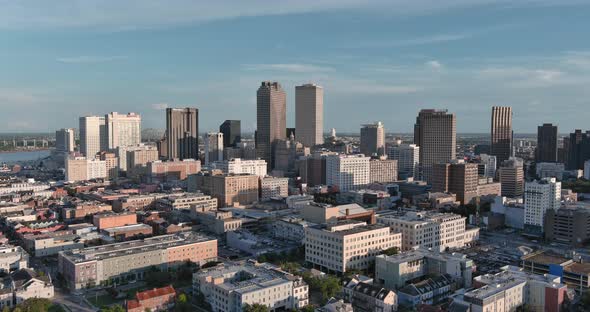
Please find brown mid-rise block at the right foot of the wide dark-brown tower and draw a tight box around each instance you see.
[431,161,479,204]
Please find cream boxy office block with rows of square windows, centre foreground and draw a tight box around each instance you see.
[305,221,402,273]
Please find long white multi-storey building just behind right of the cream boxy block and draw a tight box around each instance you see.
[377,211,479,251]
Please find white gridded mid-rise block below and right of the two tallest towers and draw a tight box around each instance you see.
[326,154,371,192]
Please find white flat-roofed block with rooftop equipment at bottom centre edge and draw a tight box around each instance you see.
[193,262,309,312]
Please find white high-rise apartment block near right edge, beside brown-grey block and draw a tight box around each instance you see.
[524,178,561,232]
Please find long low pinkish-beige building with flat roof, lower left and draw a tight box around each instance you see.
[58,232,217,289]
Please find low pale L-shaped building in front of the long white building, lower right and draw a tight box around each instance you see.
[375,249,475,289]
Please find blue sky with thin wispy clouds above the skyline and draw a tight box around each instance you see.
[0,0,590,133]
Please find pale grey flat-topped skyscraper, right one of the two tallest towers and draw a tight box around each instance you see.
[295,84,324,147]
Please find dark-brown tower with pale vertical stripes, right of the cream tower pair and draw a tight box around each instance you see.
[166,107,199,159]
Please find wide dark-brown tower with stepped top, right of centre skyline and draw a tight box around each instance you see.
[414,109,457,182]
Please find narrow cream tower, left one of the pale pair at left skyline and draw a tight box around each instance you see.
[80,116,108,159]
